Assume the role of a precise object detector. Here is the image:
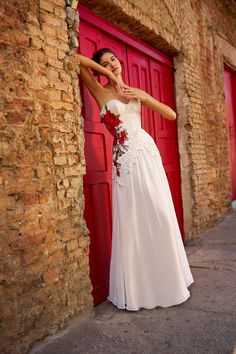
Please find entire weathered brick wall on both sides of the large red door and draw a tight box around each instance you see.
[0,0,236,354]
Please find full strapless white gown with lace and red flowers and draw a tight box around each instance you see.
[101,99,193,311]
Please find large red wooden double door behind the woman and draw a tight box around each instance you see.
[79,6,183,304]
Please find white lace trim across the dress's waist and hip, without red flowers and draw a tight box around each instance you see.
[112,129,161,186]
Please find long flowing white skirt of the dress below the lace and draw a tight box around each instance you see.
[108,150,193,311]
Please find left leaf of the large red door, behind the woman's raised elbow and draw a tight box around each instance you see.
[80,22,112,303]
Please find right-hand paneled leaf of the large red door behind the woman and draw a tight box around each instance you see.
[127,48,183,234]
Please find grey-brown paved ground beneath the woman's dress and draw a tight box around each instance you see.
[31,212,236,354]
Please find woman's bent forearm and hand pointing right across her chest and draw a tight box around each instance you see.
[121,86,176,120]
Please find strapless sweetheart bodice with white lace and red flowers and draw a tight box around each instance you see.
[100,99,159,185]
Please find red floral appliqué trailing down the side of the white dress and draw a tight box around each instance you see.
[102,106,128,176]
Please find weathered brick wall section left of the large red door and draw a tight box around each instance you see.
[0,0,92,354]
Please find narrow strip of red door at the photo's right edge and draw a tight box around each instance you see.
[224,65,236,200]
